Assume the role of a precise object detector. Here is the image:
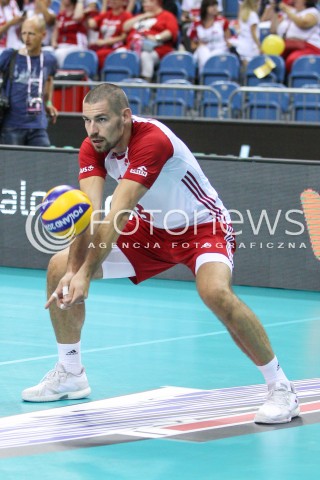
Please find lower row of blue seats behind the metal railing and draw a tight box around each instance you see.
[122,78,320,122]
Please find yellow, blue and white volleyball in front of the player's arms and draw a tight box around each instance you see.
[41,185,92,238]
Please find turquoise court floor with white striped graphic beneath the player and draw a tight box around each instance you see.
[0,268,320,480]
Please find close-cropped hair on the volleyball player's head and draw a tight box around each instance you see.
[83,83,129,115]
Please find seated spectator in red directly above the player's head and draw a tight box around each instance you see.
[88,0,132,69]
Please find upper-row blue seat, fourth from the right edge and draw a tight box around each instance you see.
[158,52,196,83]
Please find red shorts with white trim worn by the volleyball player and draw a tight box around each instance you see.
[102,220,236,284]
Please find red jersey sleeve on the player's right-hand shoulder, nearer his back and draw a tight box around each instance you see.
[123,125,173,189]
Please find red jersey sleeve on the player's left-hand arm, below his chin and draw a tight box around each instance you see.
[78,137,107,184]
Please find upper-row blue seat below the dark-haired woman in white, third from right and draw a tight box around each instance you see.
[200,53,240,85]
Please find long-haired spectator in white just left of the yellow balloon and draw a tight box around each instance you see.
[230,0,260,67]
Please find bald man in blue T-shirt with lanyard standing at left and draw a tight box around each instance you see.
[0,16,57,147]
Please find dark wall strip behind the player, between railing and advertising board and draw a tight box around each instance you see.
[49,114,319,160]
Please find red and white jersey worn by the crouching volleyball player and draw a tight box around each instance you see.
[79,116,230,229]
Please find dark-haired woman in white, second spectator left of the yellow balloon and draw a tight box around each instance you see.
[188,0,231,73]
